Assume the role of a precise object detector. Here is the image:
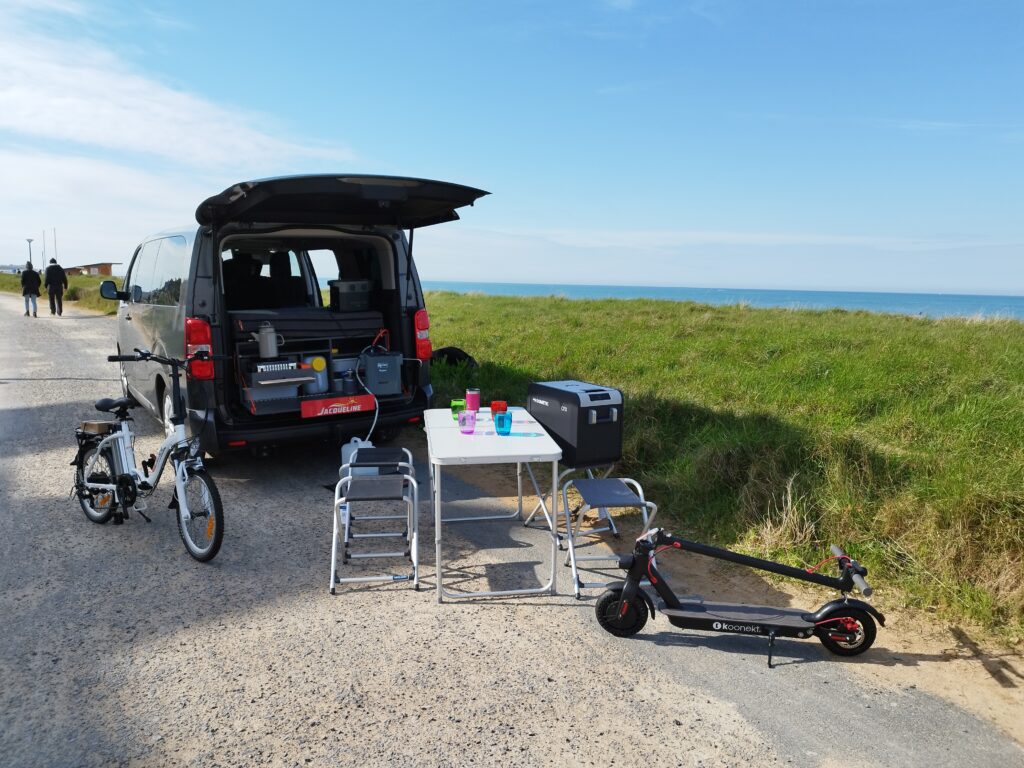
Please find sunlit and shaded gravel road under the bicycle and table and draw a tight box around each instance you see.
[0,295,1024,768]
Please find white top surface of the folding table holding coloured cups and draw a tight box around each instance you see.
[423,408,562,465]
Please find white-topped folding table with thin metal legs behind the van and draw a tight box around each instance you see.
[423,408,562,602]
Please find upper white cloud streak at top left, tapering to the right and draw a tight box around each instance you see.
[0,0,353,168]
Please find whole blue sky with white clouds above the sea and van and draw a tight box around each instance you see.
[0,0,1024,294]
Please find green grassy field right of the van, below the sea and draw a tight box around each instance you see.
[428,293,1024,638]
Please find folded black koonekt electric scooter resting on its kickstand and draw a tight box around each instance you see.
[595,528,886,668]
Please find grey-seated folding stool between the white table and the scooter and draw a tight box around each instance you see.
[562,477,657,600]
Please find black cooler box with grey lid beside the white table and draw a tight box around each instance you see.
[526,381,623,468]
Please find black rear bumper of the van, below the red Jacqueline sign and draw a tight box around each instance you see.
[188,390,428,454]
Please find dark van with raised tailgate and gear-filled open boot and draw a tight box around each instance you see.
[100,175,487,454]
